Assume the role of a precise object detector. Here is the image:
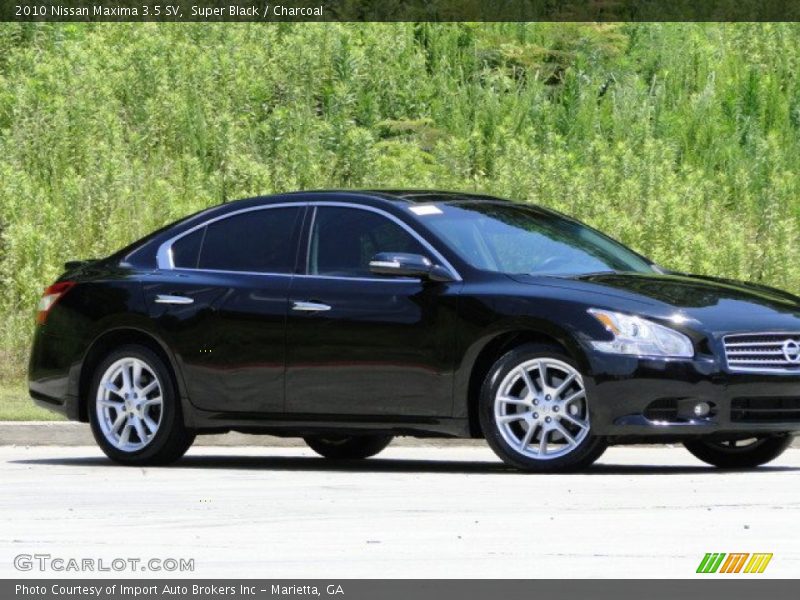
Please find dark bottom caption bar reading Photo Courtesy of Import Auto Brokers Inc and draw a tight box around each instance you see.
[0,580,797,600]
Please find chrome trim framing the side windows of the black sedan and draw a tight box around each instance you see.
[156,200,463,283]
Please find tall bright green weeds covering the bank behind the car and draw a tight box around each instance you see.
[0,23,800,381]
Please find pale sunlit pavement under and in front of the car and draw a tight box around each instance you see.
[0,446,800,578]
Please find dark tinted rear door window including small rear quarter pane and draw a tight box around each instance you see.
[172,207,301,273]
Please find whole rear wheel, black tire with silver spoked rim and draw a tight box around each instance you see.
[88,345,194,466]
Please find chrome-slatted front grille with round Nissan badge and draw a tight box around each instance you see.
[723,333,800,373]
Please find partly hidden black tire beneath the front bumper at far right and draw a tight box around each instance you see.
[683,435,793,469]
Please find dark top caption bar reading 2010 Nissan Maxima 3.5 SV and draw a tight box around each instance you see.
[0,0,800,22]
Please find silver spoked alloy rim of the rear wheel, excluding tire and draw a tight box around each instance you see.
[96,357,164,452]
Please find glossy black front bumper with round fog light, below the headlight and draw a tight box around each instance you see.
[586,352,800,439]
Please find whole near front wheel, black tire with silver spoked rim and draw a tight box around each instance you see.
[479,344,606,472]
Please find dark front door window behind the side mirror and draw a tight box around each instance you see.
[308,206,428,277]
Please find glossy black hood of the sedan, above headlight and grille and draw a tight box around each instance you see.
[514,273,800,333]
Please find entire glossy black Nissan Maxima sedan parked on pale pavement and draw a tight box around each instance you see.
[29,191,800,471]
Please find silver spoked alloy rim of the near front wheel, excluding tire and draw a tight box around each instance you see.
[494,358,589,460]
